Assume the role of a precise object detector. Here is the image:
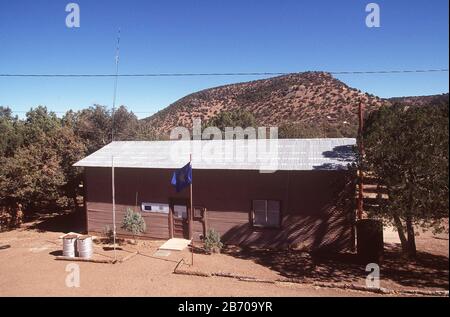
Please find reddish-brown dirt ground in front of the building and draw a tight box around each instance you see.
[0,210,449,297]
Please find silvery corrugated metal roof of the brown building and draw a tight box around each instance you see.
[74,138,356,171]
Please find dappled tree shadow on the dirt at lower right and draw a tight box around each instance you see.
[223,245,449,290]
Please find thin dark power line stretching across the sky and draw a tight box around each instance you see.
[0,68,449,78]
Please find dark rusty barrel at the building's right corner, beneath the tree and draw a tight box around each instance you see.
[356,219,384,264]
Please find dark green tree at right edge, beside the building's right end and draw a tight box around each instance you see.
[363,102,449,257]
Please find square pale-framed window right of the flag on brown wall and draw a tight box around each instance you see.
[252,200,281,228]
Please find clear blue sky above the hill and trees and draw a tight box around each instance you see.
[0,0,449,117]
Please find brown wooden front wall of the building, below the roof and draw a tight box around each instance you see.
[86,168,355,251]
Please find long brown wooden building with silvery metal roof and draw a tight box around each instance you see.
[75,139,355,251]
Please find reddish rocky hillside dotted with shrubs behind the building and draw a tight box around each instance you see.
[144,72,436,137]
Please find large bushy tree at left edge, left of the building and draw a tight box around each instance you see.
[0,106,86,210]
